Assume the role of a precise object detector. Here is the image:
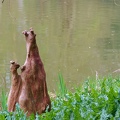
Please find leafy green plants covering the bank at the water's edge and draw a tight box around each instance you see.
[0,75,120,120]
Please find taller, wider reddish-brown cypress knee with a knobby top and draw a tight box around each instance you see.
[19,29,51,115]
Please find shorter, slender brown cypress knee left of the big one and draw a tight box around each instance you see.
[7,61,22,112]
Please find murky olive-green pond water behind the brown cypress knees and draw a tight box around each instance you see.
[0,0,120,91]
